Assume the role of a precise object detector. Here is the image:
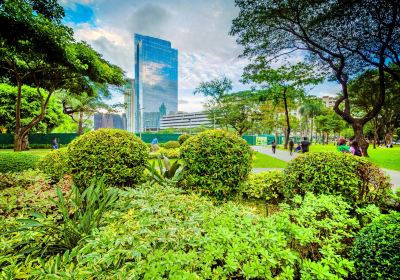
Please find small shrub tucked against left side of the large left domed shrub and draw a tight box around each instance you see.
[38,148,68,182]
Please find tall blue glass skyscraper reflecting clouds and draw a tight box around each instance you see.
[134,34,178,131]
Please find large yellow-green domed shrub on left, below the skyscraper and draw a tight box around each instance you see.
[67,129,149,188]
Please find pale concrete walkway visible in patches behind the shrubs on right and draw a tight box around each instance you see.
[252,146,400,190]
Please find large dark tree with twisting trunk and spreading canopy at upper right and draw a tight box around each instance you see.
[231,0,400,154]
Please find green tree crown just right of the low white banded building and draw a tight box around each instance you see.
[210,91,261,135]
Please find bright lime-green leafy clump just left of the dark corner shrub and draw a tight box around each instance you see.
[272,193,359,279]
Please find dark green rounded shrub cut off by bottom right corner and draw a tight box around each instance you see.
[351,212,400,279]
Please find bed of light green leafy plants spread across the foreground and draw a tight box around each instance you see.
[0,184,357,279]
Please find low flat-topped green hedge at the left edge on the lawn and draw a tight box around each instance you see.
[0,152,40,173]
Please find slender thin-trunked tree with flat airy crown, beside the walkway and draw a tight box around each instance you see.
[243,61,321,149]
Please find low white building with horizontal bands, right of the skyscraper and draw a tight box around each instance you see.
[160,112,213,129]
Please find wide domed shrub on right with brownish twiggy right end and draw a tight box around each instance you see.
[283,152,391,209]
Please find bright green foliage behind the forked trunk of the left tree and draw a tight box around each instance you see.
[0,84,63,133]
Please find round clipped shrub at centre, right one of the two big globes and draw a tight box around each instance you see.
[180,130,252,199]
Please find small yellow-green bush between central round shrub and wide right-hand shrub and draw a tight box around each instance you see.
[241,170,283,204]
